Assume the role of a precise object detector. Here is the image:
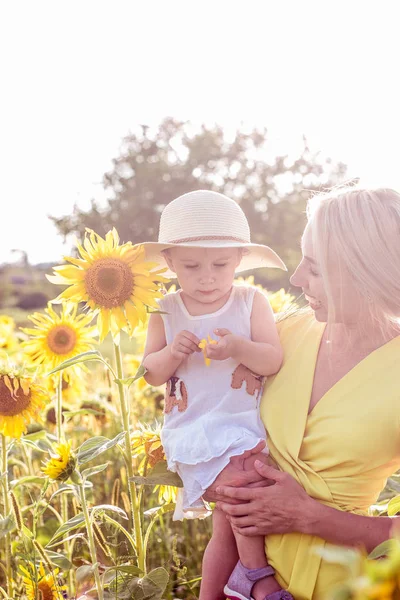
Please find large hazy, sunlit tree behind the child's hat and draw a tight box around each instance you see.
[51,118,346,287]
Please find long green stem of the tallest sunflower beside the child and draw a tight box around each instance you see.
[114,343,146,573]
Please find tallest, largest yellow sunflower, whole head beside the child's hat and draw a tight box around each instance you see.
[47,229,168,342]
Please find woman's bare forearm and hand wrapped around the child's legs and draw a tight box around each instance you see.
[216,462,396,552]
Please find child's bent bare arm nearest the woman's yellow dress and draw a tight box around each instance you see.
[207,291,283,376]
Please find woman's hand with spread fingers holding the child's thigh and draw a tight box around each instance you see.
[216,461,316,536]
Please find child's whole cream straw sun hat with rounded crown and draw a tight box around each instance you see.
[140,190,287,277]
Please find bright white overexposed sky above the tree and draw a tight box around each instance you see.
[0,0,400,263]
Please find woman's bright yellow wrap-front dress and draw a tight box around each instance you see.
[261,314,400,600]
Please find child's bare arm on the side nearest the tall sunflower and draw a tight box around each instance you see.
[143,314,200,385]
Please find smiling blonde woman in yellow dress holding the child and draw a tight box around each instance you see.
[209,187,400,600]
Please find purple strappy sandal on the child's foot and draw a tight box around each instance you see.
[224,560,293,600]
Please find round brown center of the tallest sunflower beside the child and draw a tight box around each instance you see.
[85,258,133,308]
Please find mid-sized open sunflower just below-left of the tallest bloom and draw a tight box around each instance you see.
[22,302,97,377]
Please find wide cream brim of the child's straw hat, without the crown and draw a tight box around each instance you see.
[136,240,287,279]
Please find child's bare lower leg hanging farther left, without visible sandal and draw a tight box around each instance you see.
[199,509,238,600]
